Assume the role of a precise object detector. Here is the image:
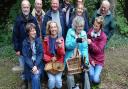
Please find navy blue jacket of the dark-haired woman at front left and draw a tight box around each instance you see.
[22,38,43,79]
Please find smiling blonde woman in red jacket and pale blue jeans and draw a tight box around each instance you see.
[43,21,65,89]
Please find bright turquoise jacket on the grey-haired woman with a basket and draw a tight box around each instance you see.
[64,28,89,65]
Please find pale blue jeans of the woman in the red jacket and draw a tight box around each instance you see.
[47,72,62,89]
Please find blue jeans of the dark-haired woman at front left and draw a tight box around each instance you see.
[31,71,41,89]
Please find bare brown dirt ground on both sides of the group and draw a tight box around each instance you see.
[0,46,128,89]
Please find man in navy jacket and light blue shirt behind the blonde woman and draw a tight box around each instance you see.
[42,0,65,38]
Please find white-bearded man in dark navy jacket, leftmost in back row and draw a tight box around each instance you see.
[12,0,40,88]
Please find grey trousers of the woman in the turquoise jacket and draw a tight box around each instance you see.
[67,71,90,89]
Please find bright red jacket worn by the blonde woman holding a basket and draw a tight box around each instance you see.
[43,36,65,63]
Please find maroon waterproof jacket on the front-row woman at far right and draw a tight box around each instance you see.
[88,28,107,66]
